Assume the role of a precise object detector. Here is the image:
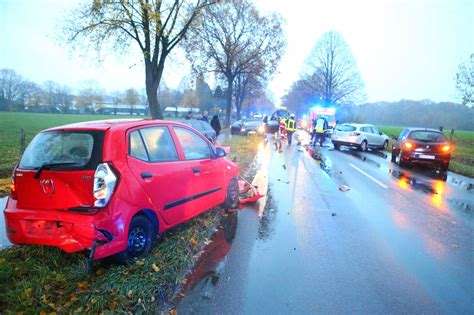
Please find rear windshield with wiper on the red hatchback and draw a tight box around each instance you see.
[19,131,94,169]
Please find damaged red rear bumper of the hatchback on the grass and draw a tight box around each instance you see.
[4,198,123,259]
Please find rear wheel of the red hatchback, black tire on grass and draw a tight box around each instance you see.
[114,215,155,264]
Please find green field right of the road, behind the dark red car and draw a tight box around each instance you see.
[377,126,474,177]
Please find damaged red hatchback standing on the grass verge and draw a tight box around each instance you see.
[4,120,239,262]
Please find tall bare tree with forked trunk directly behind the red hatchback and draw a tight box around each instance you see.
[64,0,211,118]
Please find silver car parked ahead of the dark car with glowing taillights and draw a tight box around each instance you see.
[331,124,389,151]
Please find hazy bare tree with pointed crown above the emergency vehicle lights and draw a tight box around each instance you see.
[303,31,365,105]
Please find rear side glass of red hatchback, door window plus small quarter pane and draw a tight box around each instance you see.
[130,127,179,162]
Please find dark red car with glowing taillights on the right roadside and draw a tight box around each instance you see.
[392,128,453,172]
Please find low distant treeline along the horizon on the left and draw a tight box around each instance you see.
[0,69,273,115]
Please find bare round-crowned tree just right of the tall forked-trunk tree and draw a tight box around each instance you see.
[185,0,286,126]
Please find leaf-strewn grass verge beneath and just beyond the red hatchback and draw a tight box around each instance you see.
[0,123,262,313]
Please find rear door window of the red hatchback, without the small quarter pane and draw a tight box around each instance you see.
[140,127,179,162]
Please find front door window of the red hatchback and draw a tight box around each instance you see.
[174,127,212,160]
